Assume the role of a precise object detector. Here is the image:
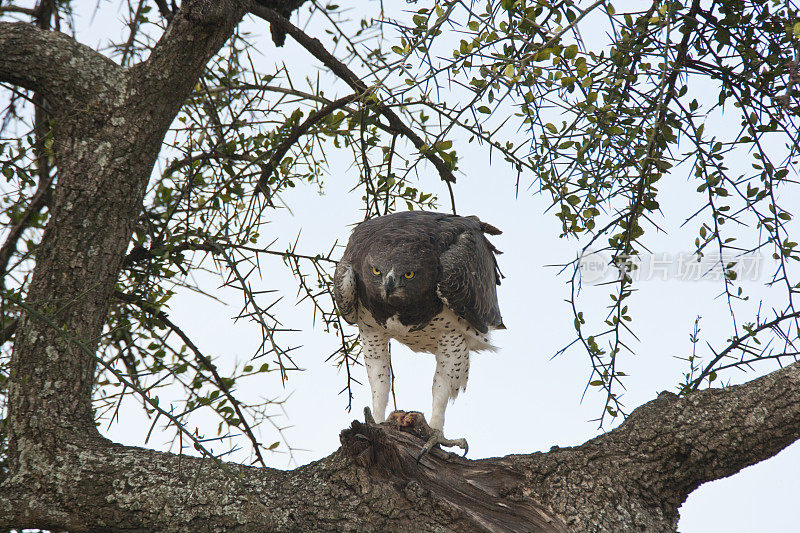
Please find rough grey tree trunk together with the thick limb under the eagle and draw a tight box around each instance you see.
[0,0,800,532]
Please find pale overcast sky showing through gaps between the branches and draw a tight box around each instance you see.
[7,2,800,533]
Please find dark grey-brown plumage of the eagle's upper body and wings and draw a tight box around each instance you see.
[334,211,502,333]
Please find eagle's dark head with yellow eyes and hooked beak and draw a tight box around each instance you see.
[361,247,436,308]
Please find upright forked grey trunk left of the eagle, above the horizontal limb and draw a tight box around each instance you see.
[0,0,250,446]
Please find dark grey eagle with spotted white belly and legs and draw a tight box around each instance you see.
[334,211,505,446]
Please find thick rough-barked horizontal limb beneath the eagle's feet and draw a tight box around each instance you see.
[0,363,800,531]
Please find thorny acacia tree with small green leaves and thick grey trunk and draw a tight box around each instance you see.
[0,0,800,531]
